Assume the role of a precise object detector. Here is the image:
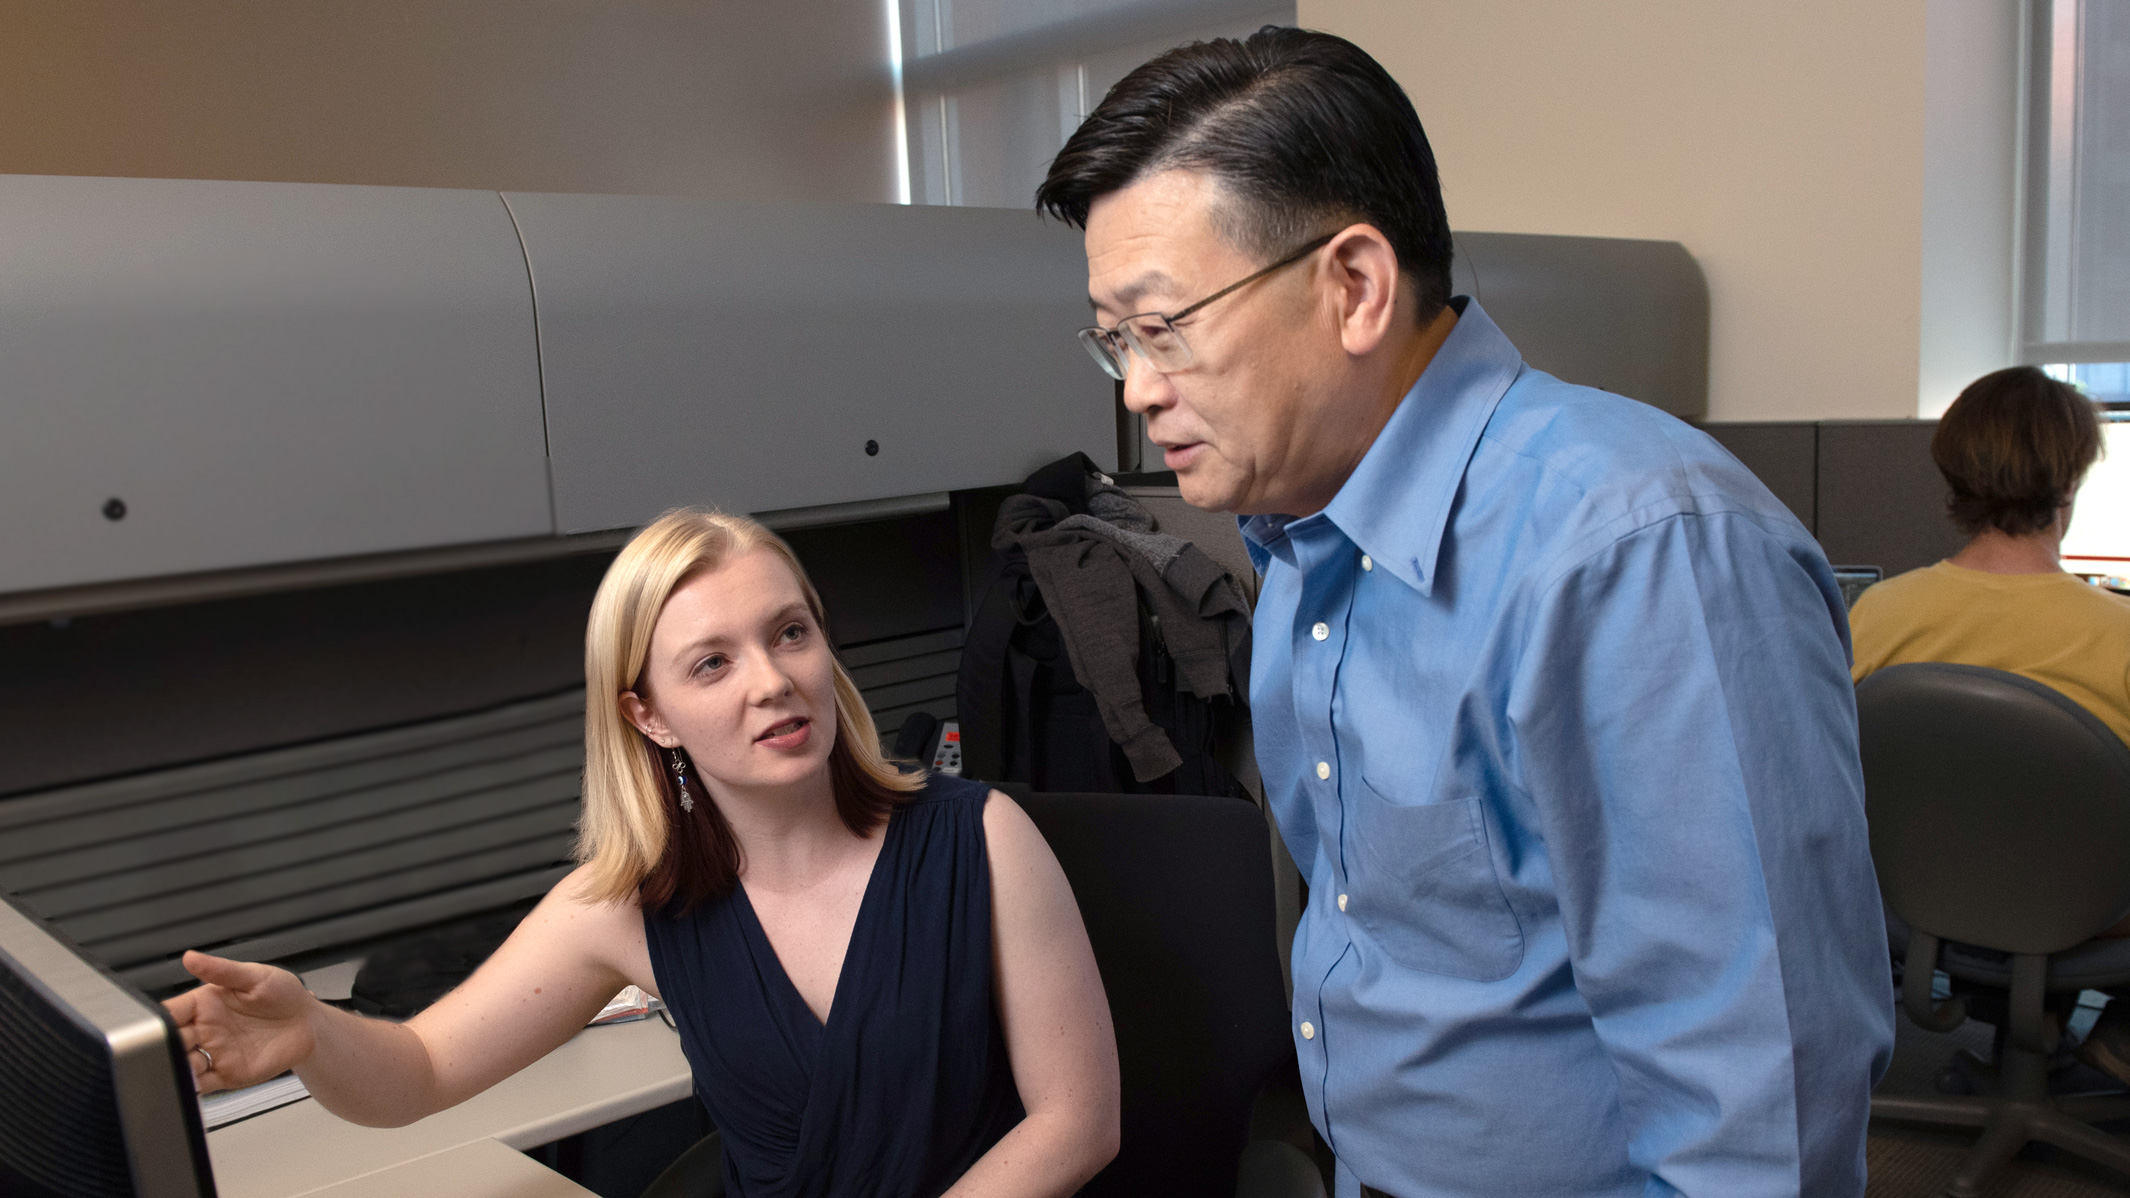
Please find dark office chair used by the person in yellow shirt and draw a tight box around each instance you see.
[1857,663,2130,1198]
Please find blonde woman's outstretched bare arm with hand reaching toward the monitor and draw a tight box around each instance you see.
[164,870,654,1128]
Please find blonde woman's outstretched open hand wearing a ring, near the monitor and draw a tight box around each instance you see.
[164,953,322,1094]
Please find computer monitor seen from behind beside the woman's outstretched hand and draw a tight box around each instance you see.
[0,893,215,1198]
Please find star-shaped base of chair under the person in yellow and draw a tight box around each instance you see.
[1870,1094,2130,1198]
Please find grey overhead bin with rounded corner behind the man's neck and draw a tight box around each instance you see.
[1453,232,1708,420]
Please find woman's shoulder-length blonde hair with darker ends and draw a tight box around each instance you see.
[577,507,924,910]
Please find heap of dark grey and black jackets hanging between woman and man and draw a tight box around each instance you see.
[954,454,1250,797]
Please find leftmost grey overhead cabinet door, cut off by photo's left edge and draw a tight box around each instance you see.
[0,175,554,593]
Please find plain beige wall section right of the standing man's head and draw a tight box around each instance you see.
[1299,0,1926,420]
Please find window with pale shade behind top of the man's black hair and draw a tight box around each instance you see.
[897,0,1295,209]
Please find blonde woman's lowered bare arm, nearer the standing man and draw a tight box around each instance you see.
[948,791,1118,1198]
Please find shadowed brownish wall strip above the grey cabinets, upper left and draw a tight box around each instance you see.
[0,0,895,200]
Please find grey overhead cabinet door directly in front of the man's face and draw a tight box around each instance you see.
[505,192,1116,533]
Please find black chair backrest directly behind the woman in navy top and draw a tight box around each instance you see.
[1020,795,1293,1198]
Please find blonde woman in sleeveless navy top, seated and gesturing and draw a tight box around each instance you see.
[168,509,1118,1198]
